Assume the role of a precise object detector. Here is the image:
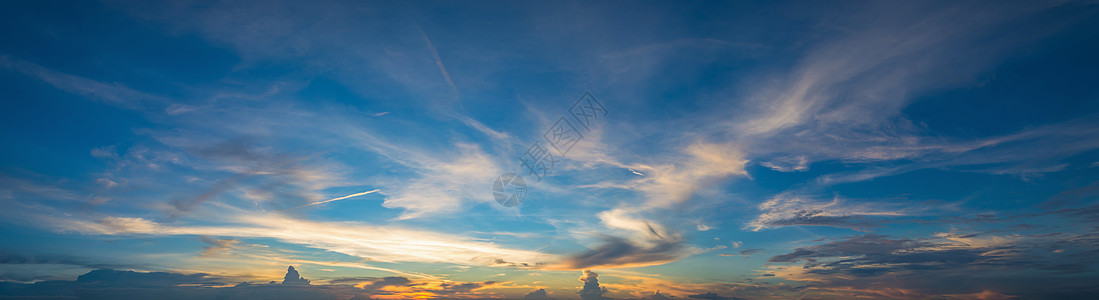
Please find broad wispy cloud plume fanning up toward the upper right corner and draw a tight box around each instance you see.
[733,4,1028,135]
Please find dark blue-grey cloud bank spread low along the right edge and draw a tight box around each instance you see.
[769,232,1099,299]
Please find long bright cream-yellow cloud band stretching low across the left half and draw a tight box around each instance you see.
[38,211,558,268]
